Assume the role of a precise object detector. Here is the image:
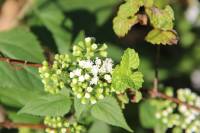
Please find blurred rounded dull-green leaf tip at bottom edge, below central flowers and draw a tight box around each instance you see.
[88,121,111,133]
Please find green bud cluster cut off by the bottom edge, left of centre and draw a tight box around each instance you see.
[44,116,86,133]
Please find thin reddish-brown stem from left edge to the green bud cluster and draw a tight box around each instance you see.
[0,57,42,68]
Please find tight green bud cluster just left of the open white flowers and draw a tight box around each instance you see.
[39,54,71,94]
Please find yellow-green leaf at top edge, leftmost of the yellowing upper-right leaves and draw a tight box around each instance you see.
[113,0,143,37]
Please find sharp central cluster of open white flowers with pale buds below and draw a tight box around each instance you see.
[70,58,113,104]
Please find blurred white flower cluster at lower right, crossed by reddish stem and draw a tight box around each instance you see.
[156,89,200,133]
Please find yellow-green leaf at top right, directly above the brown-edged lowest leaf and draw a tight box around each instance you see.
[145,5,174,30]
